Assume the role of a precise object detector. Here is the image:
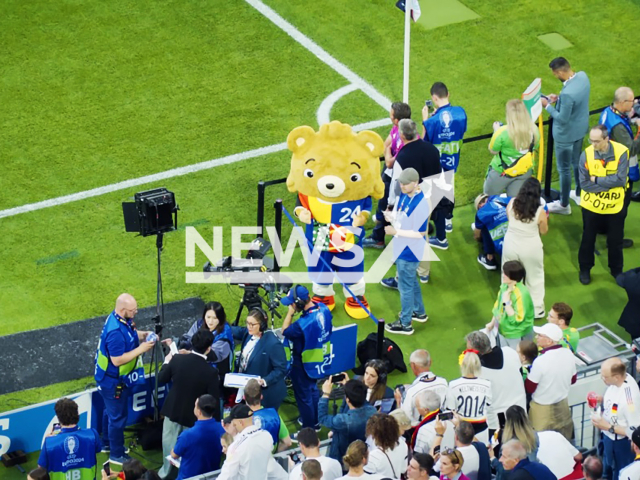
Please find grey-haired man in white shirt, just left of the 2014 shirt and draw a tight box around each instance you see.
[395,350,449,427]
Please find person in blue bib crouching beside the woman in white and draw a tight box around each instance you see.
[472,193,511,270]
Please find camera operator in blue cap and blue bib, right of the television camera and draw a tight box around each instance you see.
[280,285,333,429]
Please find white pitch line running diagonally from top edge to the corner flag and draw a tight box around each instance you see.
[245,0,391,110]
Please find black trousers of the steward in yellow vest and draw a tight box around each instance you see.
[578,205,627,276]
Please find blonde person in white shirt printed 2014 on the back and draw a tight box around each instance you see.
[447,352,497,445]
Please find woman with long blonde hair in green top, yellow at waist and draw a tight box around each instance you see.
[484,99,540,197]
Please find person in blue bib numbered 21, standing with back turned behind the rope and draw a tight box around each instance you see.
[422,82,467,249]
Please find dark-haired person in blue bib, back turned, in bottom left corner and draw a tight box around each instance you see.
[38,398,102,480]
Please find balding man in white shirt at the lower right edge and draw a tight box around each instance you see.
[591,358,640,479]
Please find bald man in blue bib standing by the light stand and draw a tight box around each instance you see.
[94,293,155,465]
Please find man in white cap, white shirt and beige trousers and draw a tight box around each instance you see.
[525,323,576,440]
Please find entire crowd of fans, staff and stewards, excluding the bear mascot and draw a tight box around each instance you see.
[29,57,640,480]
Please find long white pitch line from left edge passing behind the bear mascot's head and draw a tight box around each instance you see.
[0,118,391,218]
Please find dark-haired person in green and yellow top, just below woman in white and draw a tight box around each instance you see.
[487,260,534,350]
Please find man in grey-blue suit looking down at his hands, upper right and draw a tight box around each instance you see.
[542,57,591,215]
